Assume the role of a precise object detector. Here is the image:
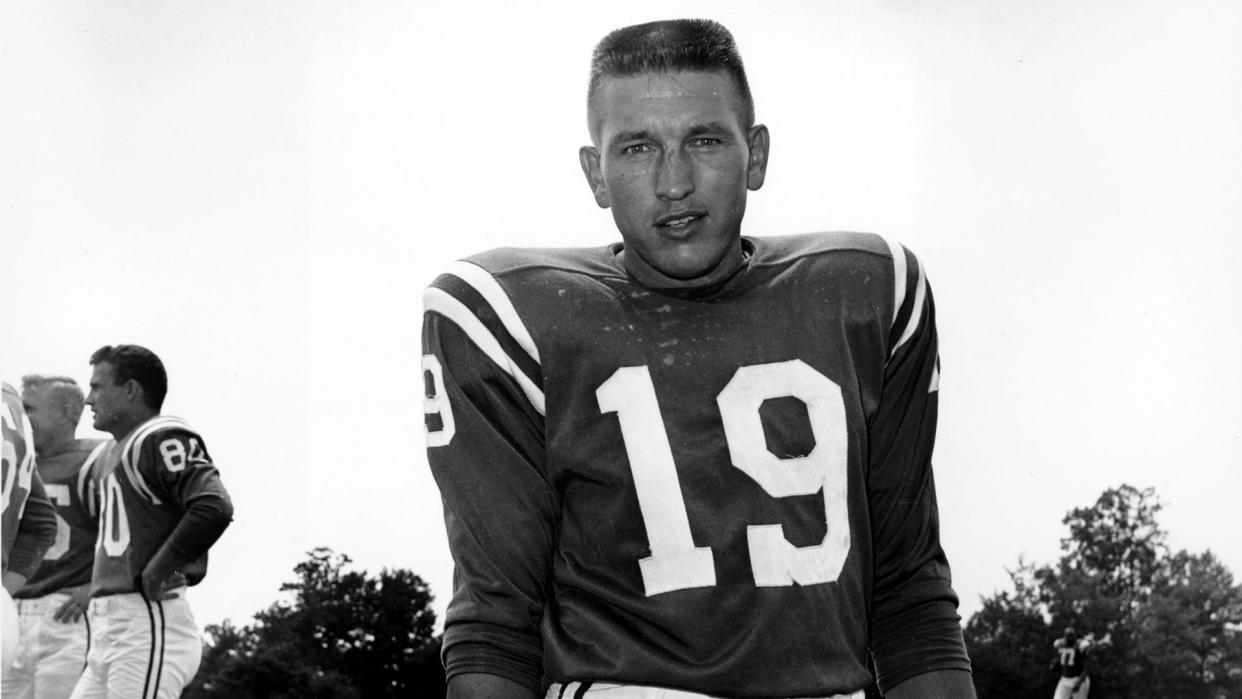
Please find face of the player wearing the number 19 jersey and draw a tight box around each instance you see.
[580,71,768,286]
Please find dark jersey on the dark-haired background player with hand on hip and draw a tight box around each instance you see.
[91,415,229,596]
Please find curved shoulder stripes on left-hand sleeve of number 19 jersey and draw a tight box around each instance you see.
[422,261,544,415]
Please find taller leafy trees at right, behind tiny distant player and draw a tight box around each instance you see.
[965,484,1242,699]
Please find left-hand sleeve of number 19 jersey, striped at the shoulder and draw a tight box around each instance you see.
[422,263,559,692]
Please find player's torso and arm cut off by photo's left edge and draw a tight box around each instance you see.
[0,382,56,595]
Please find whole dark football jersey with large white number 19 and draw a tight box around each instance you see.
[422,233,969,697]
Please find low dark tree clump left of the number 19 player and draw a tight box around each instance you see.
[183,548,445,699]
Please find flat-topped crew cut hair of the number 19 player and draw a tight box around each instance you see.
[586,20,755,135]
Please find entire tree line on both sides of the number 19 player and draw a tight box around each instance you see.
[183,484,1242,699]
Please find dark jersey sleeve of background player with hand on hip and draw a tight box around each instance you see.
[138,427,232,569]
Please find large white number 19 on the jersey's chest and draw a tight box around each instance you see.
[595,360,850,597]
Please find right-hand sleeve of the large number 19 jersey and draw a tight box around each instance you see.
[868,246,970,692]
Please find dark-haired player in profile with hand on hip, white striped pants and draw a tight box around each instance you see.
[73,345,232,699]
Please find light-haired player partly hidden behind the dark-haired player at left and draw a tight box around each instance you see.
[4,375,104,699]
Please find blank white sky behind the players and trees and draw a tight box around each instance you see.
[0,0,1242,625]
